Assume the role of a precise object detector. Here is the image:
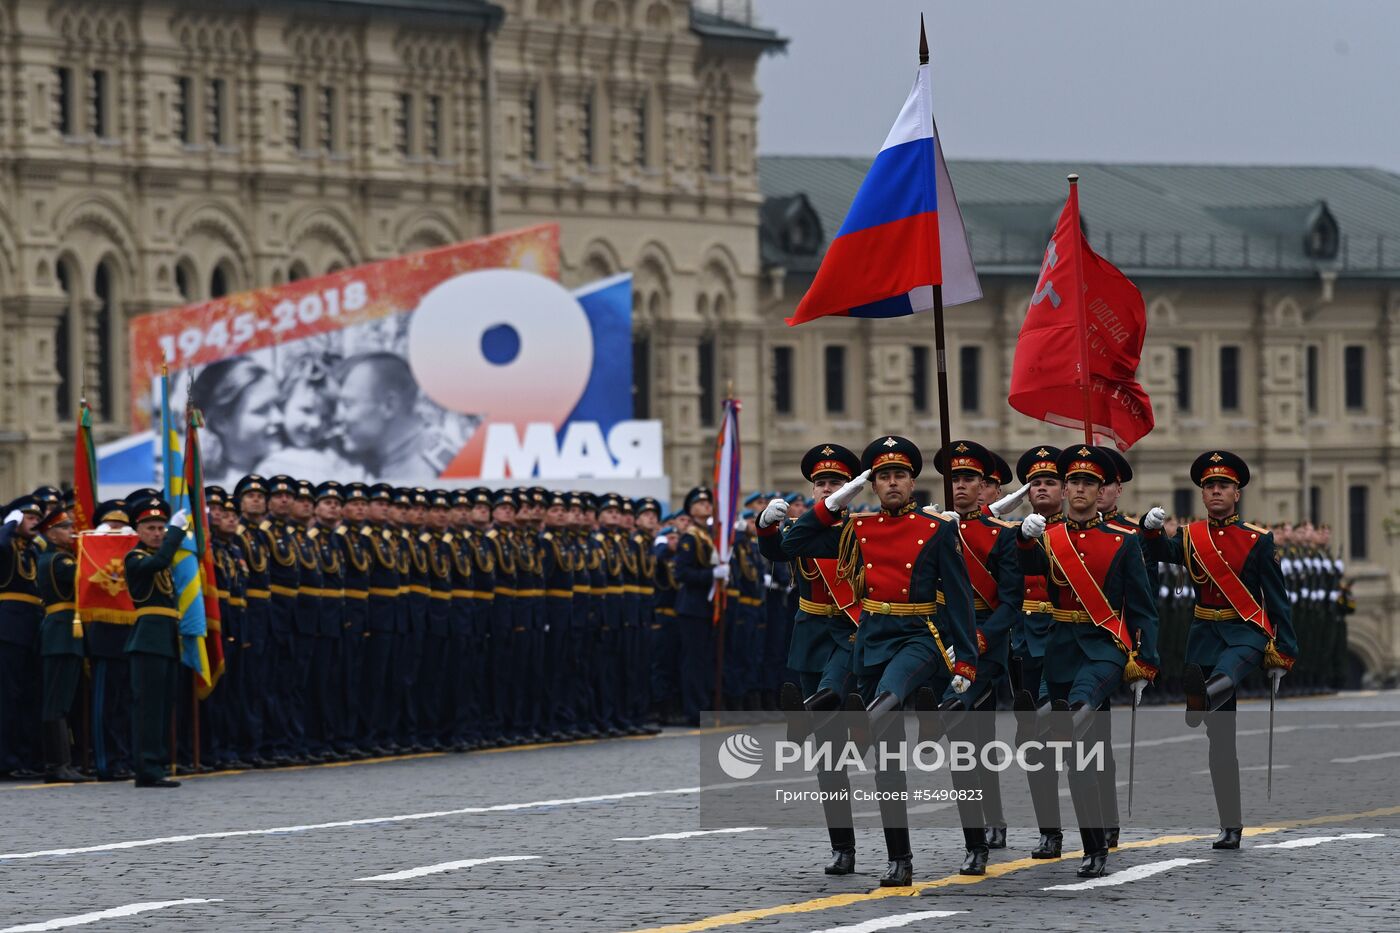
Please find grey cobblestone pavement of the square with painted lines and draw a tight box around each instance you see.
[0,692,1400,933]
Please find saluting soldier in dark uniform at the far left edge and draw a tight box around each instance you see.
[0,496,43,779]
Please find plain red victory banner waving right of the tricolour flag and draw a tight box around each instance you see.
[1008,175,1155,450]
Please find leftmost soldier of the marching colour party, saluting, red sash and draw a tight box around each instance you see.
[757,444,861,874]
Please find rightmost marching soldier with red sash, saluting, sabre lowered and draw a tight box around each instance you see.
[1142,450,1298,849]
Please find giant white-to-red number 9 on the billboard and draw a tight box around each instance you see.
[409,269,594,475]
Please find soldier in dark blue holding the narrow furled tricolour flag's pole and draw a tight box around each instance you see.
[675,486,729,726]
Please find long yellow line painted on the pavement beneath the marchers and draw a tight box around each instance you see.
[630,807,1400,933]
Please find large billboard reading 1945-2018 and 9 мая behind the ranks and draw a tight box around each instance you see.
[124,224,662,486]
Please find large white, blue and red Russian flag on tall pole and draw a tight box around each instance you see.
[787,64,981,325]
